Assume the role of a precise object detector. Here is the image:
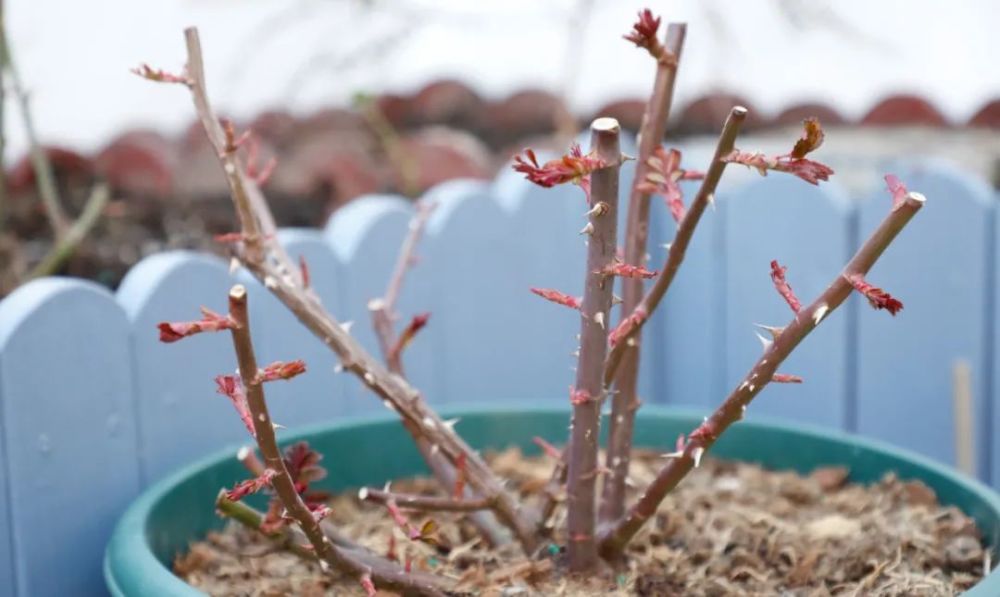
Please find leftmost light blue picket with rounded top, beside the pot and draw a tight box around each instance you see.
[0,278,140,595]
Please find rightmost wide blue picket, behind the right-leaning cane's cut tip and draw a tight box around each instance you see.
[856,160,995,476]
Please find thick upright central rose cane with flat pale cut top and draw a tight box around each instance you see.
[566,118,622,572]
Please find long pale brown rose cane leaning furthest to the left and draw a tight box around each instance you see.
[140,28,538,553]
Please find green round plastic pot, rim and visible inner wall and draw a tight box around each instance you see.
[104,406,1000,597]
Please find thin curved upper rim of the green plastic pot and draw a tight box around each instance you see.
[103,402,1000,597]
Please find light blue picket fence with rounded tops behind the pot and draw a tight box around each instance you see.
[0,147,1000,596]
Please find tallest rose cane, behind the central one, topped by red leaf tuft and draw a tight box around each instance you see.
[600,13,687,521]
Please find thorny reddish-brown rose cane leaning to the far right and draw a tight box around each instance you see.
[600,193,925,560]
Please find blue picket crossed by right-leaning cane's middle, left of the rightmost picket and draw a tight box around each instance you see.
[720,172,853,428]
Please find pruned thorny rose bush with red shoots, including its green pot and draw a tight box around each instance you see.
[106,10,1000,595]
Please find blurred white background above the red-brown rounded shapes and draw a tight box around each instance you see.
[6,0,1000,160]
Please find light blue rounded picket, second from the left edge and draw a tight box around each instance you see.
[117,251,245,483]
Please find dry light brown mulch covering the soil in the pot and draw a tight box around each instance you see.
[174,449,991,597]
